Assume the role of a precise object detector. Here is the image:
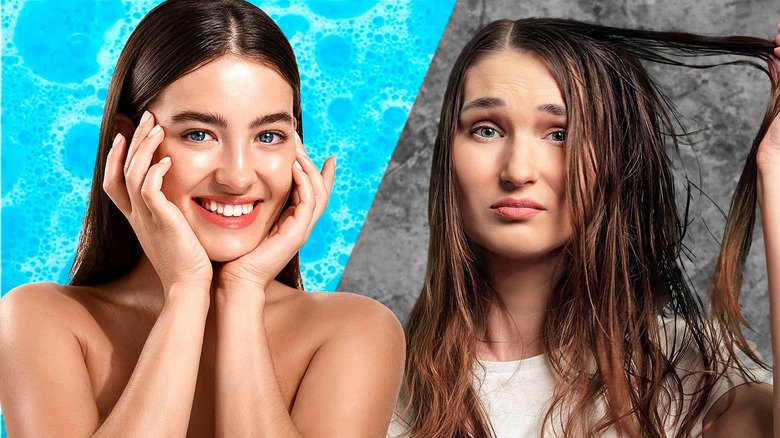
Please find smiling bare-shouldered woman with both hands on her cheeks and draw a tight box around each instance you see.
[0,0,403,438]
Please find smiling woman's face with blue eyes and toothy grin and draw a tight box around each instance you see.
[148,56,295,261]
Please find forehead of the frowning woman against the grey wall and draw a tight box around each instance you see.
[463,50,563,105]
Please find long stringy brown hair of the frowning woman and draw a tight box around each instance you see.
[404,19,780,438]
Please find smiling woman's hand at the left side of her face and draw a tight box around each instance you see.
[103,111,212,296]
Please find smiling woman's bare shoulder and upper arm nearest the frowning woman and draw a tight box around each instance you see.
[280,292,405,437]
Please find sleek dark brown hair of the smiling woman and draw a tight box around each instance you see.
[70,0,303,288]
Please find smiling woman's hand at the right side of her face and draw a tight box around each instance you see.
[219,133,336,291]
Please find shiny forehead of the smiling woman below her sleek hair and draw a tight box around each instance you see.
[153,55,293,116]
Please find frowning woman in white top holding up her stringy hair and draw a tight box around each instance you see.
[389,19,780,438]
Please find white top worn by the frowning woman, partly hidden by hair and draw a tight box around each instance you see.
[387,319,772,438]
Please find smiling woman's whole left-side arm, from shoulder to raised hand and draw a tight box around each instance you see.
[0,113,211,437]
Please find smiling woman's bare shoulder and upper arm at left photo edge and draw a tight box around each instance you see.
[0,283,104,436]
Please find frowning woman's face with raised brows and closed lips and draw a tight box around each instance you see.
[452,51,572,260]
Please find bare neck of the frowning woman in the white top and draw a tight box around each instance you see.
[477,255,557,362]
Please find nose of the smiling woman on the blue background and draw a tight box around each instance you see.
[214,141,257,194]
